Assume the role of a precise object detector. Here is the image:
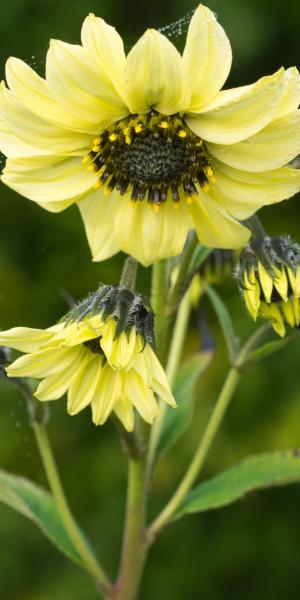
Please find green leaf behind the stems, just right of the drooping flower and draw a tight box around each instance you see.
[158,350,213,455]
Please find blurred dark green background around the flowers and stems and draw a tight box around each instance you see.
[0,0,300,600]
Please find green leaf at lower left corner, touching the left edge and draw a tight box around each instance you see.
[0,470,83,566]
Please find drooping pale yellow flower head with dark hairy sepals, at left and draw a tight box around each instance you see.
[0,285,175,431]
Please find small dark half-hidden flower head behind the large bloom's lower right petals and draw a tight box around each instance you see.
[190,248,238,307]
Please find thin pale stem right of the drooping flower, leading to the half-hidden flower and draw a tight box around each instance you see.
[148,292,191,475]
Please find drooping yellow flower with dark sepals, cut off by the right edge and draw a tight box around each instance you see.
[237,237,300,337]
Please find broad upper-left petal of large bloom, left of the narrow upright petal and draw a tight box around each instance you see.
[46,40,128,129]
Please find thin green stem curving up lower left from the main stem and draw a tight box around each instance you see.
[32,422,111,594]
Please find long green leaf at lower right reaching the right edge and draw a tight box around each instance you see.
[175,450,300,519]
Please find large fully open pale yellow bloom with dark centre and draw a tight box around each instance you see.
[0,4,300,265]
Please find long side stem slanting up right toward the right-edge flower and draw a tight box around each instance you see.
[147,326,266,543]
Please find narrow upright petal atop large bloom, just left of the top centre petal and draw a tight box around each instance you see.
[81,14,126,103]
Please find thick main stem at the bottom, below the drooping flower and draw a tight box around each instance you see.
[112,458,147,600]
